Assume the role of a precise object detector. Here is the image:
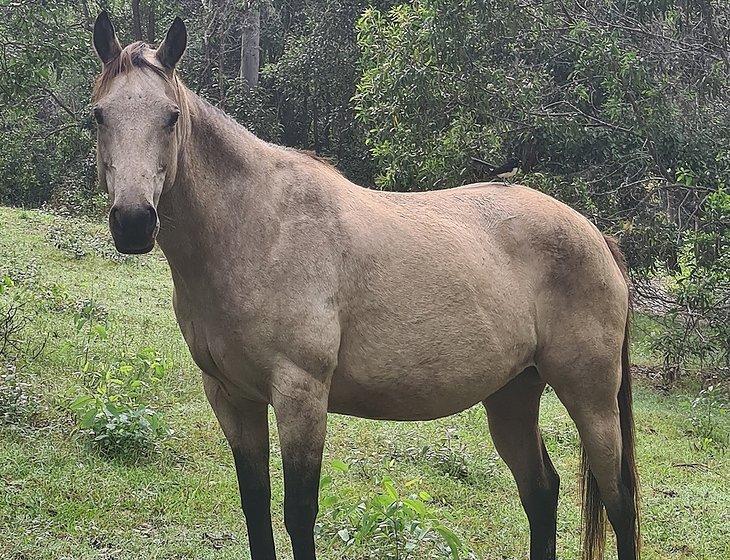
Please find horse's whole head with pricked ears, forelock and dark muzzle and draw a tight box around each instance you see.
[93,12,189,253]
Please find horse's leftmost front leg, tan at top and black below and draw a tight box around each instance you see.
[203,375,276,560]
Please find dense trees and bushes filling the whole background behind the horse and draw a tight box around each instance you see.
[0,0,730,375]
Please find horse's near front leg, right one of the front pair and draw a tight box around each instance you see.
[271,365,329,560]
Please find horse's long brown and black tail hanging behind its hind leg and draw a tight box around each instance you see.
[581,236,641,560]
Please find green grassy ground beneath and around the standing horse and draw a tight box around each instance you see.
[0,208,730,560]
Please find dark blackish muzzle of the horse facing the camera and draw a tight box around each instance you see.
[109,204,158,255]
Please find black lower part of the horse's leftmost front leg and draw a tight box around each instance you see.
[233,449,276,560]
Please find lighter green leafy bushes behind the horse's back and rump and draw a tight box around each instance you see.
[355,0,730,375]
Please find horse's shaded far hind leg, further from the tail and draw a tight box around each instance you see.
[484,368,560,560]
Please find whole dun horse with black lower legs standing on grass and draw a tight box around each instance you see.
[93,13,639,560]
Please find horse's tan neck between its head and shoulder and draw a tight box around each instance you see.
[158,93,276,280]
